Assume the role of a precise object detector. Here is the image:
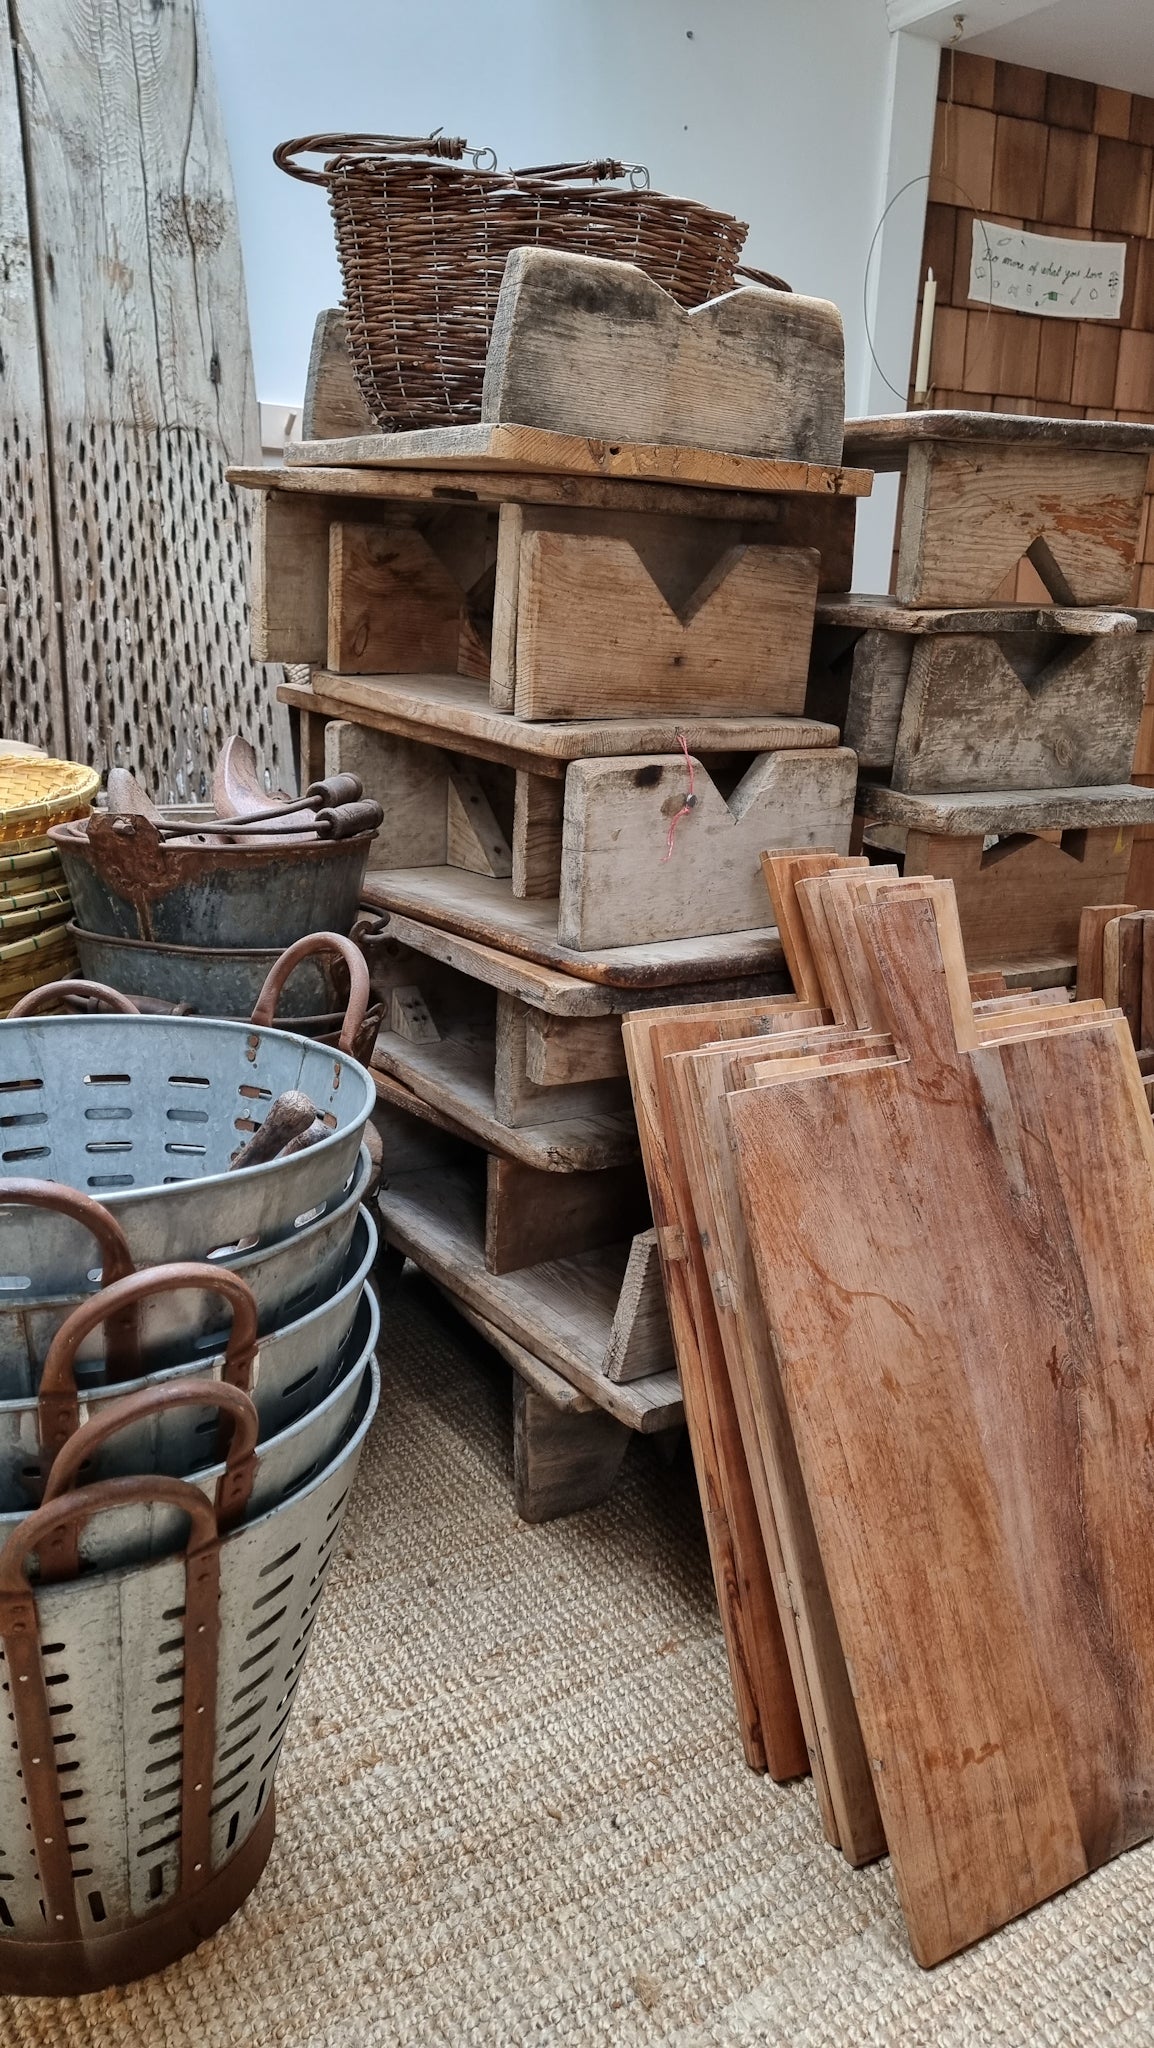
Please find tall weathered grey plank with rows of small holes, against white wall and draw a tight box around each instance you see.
[17,0,291,801]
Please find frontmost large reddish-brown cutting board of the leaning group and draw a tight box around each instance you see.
[728,883,1154,1964]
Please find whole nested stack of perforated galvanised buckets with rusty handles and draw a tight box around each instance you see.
[0,966,379,1995]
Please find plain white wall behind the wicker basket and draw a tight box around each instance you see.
[203,0,937,588]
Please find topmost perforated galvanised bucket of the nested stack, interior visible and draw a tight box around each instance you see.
[0,1016,375,1294]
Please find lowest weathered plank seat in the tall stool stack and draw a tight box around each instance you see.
[379,1169,685,1434]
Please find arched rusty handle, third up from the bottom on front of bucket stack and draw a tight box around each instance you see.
[37,1260,256,1452]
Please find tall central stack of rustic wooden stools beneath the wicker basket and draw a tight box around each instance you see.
[238,250,869,1518]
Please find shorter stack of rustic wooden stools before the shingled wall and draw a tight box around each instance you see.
[810,412,1154,983]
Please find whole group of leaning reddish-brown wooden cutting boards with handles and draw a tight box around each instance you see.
[625,852,1154,1964]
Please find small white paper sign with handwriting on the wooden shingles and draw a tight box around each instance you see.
[970,221,1125,319]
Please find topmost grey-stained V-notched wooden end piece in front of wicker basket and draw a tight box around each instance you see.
[482,246,844,463]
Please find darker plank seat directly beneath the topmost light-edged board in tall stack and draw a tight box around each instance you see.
[230,467,857,589]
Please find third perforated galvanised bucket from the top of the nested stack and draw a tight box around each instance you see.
[0,1210,377,1526]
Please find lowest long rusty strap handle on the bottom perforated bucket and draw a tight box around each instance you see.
[0,1475,219,1916]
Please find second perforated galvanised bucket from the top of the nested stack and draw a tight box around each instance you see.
[0,1155,373,1401]
